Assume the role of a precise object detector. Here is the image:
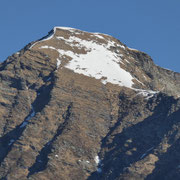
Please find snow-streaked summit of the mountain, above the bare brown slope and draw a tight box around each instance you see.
[26,27,179,97]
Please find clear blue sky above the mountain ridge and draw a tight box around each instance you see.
[0,0,180,72]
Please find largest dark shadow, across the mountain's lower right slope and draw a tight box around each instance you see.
[88,94,180,180]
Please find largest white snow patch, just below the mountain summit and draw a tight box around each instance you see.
[40,37,134,88]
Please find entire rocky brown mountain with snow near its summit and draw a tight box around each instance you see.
[0,27,180,180]
